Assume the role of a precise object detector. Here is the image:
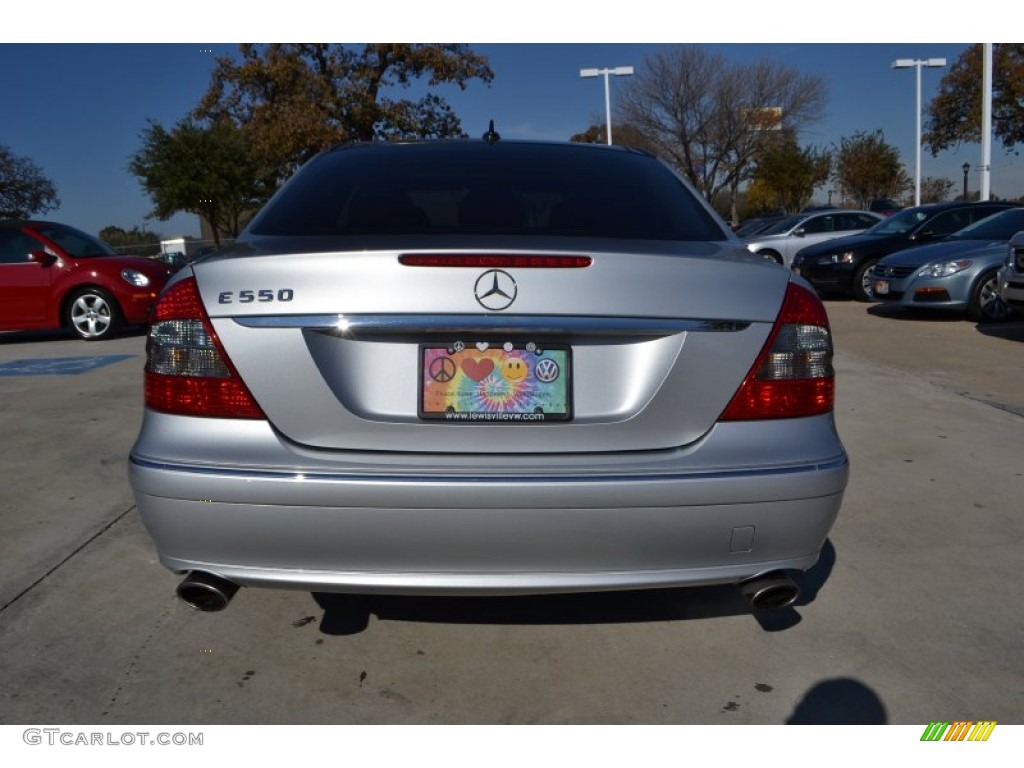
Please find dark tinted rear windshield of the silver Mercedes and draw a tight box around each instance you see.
[249,141,728,241]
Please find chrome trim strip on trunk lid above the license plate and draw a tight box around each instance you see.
[231,314,751,337]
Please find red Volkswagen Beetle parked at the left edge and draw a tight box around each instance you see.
[0,219,172,341]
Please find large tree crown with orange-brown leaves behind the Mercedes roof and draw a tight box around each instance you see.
[194,43,494,179]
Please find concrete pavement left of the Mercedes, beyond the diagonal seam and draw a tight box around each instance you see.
[0,333,145,605]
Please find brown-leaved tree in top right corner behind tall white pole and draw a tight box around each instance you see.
[923,43,1024,155]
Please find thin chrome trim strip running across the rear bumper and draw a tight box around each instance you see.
[130,456,849,485]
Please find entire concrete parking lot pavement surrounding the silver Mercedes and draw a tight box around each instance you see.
[0,309,1024,724]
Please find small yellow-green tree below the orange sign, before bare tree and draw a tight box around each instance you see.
[748,129,831,213]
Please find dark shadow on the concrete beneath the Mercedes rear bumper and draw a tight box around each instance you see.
[313,541,836,635]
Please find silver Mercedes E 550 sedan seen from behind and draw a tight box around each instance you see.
[130,140,848,610]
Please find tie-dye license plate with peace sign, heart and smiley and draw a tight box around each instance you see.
[419,342,572,424]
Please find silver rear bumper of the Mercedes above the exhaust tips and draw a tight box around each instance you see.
[131,414,849,594]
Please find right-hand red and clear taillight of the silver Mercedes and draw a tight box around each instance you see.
[719,283,836,421]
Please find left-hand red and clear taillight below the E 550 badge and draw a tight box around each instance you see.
[145,278,266,419]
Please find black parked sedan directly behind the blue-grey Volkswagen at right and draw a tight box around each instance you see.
[793,203,1016,301]
